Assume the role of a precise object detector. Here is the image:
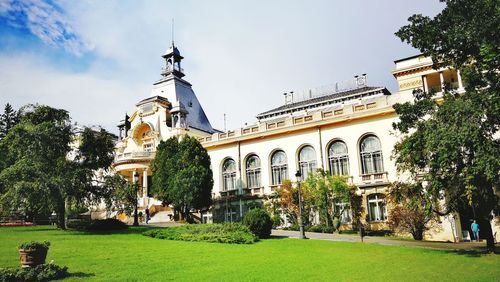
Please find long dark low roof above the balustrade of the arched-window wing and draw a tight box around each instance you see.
[257,86,391,119]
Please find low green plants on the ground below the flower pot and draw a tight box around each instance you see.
[0,263,69,282]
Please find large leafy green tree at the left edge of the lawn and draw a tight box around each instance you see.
[0,106,117,228]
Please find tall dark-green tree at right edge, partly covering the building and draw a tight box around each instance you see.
[393,0,500,251]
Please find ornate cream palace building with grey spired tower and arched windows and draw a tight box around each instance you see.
[114,46,500,241]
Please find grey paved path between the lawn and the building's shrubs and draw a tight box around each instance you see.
[271,230,486,250]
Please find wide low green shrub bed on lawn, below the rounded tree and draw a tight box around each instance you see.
[142,223,258,244]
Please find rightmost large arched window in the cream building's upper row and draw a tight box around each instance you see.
[360,135,384,174]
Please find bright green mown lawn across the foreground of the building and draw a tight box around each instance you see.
[0,227,500,281]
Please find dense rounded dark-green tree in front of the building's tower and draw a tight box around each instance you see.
[152,136,213,222]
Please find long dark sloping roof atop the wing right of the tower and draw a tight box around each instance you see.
[257,86,391,120]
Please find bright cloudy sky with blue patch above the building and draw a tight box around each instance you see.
[0,0,444,133]
